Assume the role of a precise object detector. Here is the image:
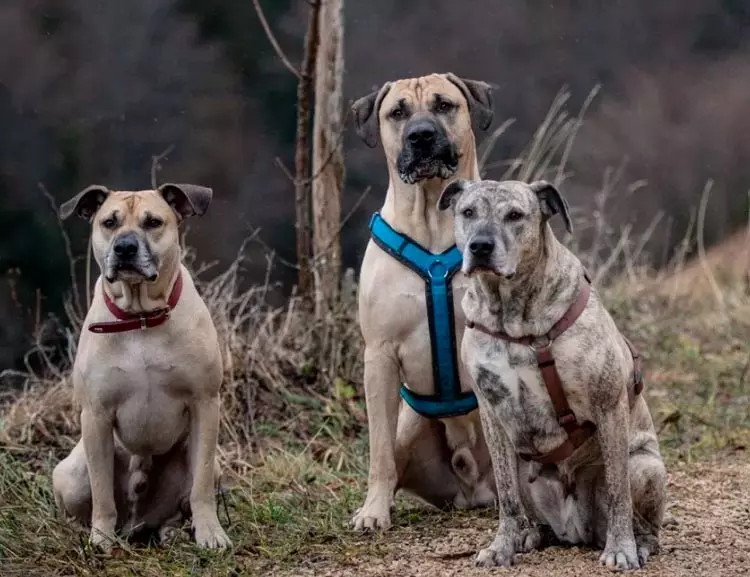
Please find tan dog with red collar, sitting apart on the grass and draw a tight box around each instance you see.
[52,184,230,549]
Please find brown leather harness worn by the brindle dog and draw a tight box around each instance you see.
[466,273,643,464]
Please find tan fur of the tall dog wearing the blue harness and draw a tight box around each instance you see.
[353,74,495,530]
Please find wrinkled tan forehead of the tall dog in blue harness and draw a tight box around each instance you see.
[380,74,466,121]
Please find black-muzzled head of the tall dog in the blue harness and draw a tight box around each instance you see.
[352,73,493,184]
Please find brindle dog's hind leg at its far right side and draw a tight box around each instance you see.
[629,448,667,567]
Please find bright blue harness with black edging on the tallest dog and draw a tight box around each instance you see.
[370,212,477,419]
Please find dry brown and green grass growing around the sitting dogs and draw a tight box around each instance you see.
[0,86,750,576]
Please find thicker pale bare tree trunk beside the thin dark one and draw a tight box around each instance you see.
[312,0,344,314]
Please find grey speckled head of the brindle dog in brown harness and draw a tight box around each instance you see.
[438,180,572,282]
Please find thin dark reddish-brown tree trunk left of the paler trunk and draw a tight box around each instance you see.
[294,0,320,297]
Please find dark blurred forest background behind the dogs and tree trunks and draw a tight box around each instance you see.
[0,0,750,369]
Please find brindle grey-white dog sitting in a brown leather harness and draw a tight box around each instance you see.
[438,180,667,570]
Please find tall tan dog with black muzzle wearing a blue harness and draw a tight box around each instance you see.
[353,74,494,529]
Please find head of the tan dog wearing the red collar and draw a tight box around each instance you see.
[60,184,213,283]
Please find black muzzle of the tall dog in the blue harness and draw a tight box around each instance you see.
[397,117,458,184]
